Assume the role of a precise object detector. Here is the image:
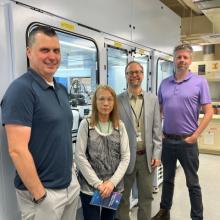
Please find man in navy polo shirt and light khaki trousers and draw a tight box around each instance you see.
[1,26,79,220]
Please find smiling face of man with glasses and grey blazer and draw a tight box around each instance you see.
[125,63,144,88]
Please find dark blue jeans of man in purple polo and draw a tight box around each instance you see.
[160,138,203,220]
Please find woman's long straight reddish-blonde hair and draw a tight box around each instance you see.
[90,85,119,128]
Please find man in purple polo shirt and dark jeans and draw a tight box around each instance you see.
[152,44,213,220]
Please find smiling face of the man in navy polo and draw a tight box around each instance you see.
[27,32,61,82]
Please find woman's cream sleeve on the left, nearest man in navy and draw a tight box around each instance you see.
[75,119,102,188]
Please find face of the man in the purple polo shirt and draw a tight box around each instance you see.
[174,50,192,73]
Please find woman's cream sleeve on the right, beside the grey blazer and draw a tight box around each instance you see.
[110,121,130,187]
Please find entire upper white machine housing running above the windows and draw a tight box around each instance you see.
[10,0,181,53]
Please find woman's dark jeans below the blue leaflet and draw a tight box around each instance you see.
[80,192,116,220]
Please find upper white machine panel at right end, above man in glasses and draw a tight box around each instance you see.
[132,0,181,54]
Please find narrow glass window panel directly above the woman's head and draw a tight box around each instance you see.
[107,47,128,94]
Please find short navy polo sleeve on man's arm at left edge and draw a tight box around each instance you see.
[1,81,35,127]
